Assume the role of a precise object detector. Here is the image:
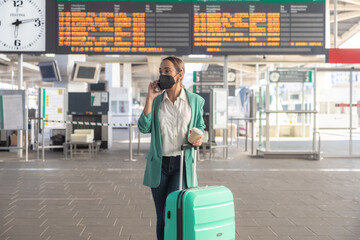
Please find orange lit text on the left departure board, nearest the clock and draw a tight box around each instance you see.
[58,12,163,53]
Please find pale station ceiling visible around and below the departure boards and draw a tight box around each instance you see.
[0,0,360,92]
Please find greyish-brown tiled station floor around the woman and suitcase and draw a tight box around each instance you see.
[0,132,360,240]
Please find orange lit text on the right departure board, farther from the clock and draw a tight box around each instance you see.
[193,12,322,52]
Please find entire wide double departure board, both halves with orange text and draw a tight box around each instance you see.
[56,0,325,55]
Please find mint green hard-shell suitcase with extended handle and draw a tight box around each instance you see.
[164,144,235,240]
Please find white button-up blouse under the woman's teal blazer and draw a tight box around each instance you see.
[159,89,191,157]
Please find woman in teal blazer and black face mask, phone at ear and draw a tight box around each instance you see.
[138,57,205,240]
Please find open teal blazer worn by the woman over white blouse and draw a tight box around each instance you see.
[138,89,205,188]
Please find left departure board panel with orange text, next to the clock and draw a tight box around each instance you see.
[57,0,192,55]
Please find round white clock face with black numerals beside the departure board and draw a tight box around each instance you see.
[0,0,46,52]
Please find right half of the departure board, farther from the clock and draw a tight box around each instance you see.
[192,0,325,55]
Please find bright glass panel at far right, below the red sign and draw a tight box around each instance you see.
[317,71,352,157]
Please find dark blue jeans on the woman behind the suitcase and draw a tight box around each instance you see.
[151,156,186,240]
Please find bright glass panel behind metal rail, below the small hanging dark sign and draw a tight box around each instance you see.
[269,82,314,152]
